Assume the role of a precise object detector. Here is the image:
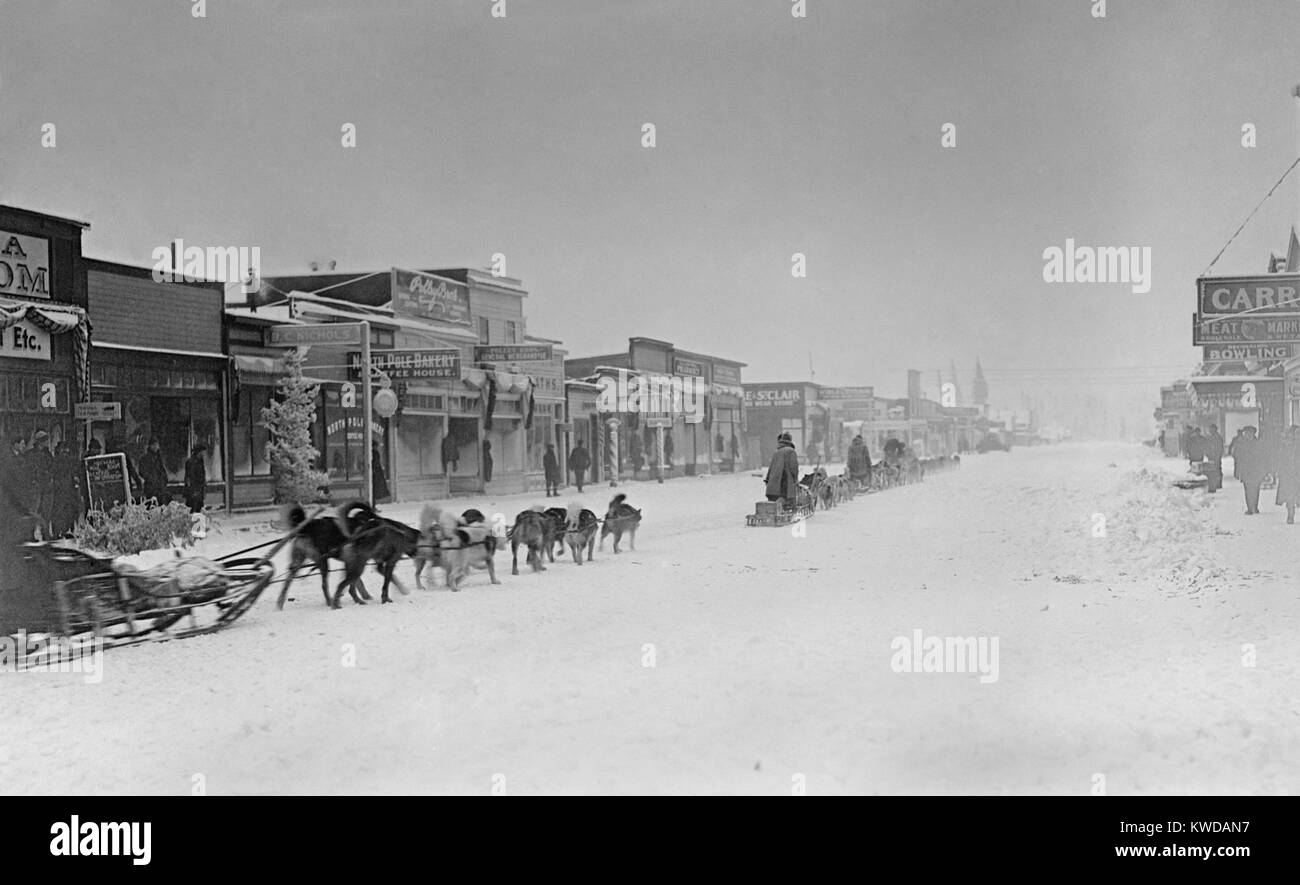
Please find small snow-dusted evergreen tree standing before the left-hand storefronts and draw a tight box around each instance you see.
[261,348,329,504]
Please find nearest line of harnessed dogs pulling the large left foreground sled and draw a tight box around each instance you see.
[276,494,641,609]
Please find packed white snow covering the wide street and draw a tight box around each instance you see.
[0,444,1300,795]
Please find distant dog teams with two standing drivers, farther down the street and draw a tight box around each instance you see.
[764,433,961,511]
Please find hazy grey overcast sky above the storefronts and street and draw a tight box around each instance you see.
[0,0,1300,428]
